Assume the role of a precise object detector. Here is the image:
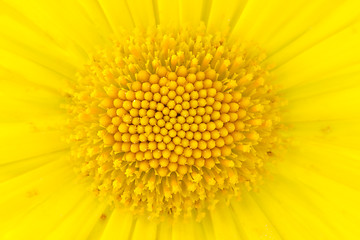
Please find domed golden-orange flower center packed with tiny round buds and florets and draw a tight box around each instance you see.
[68,25,280,217]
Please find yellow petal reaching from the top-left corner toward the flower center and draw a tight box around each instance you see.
[1,0,107,57]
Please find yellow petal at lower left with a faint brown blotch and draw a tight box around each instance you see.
[0,158,74,239]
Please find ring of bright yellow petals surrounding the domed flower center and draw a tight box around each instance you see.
[0,0,360,240]
